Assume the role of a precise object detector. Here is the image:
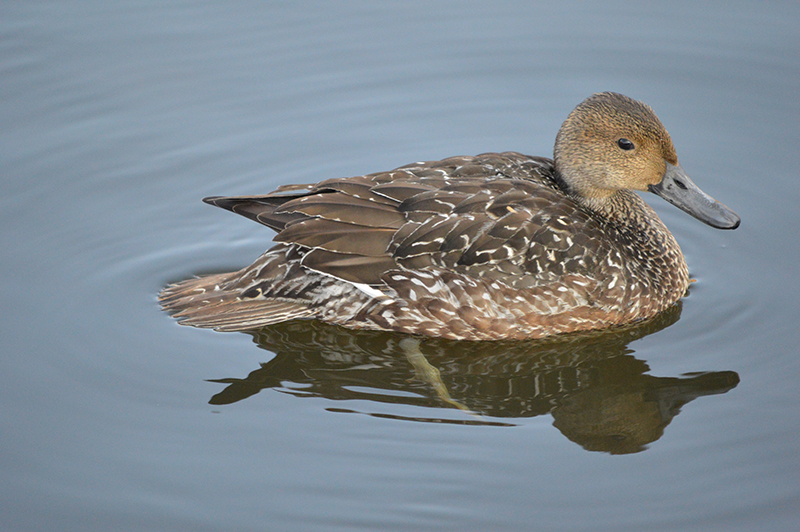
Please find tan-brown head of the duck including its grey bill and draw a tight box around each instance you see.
[554,92,740,229]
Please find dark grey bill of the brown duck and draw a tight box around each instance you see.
[647,163,740,229]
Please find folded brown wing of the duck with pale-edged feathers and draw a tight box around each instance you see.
[204,152,592,287]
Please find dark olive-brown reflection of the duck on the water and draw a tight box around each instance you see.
[205,306,739,453]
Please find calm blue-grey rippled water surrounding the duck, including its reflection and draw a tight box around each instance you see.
[0,0,800,531]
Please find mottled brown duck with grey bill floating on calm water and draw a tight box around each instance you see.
[159,92,740,341]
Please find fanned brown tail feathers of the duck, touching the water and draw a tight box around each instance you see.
[159,274,315,332]
